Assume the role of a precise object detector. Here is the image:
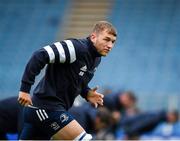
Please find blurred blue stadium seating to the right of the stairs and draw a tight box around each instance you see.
[92,0,180,109]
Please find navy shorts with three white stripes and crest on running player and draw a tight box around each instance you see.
[20,107,74,140]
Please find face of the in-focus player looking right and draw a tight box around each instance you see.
[91,30,116,56]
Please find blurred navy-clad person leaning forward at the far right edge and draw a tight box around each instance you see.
[116,110,180,140]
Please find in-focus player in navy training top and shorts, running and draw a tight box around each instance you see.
[18,21,117,140]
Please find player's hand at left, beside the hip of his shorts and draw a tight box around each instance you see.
[18,91,33,106]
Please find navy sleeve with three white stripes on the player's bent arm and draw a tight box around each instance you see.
[20,40,77,93]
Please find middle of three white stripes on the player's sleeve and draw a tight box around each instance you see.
[54,42,66,63]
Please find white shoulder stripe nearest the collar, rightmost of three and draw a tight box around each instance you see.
[64,40,76,63]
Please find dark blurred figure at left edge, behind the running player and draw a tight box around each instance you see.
[0,96,22,140]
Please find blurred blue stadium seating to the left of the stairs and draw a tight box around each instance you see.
[0,0,68,98]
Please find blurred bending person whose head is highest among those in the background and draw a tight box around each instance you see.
[101,91,139,139]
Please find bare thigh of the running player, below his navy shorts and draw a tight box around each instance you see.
[52,120,85,140]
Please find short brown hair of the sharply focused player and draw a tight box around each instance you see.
[93,21,117,36]
